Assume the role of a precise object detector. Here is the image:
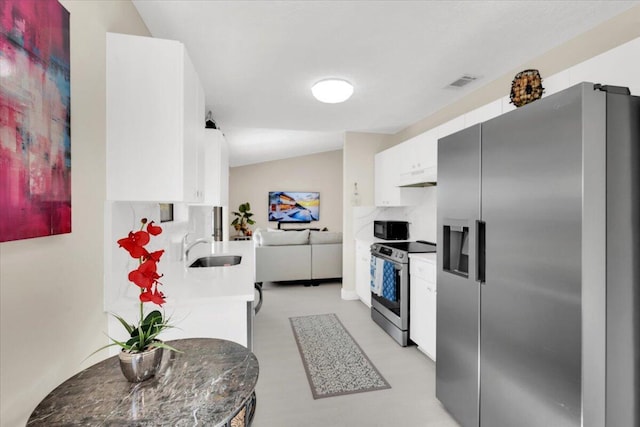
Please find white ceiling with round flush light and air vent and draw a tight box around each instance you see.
[133,0,639,166]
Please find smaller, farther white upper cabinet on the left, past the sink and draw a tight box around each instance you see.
[201,129,229,206]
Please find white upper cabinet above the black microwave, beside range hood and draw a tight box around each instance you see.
[374,145,423,207]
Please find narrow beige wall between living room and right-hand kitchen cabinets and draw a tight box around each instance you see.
[342,132,392,299]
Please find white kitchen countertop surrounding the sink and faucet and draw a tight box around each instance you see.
[106,241,255,312]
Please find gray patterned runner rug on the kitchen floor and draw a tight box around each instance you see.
[289,314,391,399]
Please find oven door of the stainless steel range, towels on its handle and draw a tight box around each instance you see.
[371,254,409,330]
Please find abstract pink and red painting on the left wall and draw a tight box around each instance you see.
[0,0,71,242]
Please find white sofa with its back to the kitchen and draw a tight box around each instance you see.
[253,230,342,284]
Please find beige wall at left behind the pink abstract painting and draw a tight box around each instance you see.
[0,0,149,427]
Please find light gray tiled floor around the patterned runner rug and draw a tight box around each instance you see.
[253,283,458,427]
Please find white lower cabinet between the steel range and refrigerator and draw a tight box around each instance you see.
[409,254,437,361]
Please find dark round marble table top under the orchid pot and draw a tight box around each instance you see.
[27,338,259,426]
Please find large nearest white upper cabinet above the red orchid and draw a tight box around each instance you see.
[106,33,205,202]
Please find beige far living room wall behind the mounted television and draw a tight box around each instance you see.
[229,150,342,236]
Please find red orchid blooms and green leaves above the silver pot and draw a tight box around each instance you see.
[96,218,178,353]
